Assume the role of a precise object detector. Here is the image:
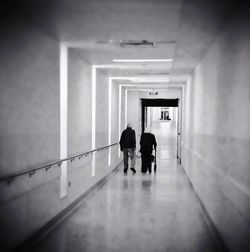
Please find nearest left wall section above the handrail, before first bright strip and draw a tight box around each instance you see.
[0,20,59,175]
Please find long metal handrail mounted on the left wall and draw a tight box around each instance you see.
[0,143,118,184]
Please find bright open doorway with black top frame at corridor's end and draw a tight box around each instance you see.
[141,99,181,162]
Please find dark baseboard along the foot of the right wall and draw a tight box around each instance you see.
[180,165,230,252]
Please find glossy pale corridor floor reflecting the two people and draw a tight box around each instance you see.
[30,121,220,252]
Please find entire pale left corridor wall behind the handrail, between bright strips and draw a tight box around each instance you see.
[0,15,120,251]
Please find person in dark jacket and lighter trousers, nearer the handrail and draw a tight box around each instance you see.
[120,123,136,174]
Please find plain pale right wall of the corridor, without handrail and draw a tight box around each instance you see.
[182,4,250,251]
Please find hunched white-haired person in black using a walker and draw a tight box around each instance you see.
[140,128,157,173]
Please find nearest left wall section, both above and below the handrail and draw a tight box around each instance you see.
[0,16,60,251]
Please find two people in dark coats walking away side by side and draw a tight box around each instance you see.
[120,123,157,174]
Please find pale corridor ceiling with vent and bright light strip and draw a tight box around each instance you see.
[11,0,236,87]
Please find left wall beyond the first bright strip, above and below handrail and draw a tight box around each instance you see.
[67,48,120,224]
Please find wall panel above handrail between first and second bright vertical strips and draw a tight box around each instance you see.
[68,48,92,155]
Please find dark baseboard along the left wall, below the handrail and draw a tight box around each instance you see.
[13,161,122,252]
